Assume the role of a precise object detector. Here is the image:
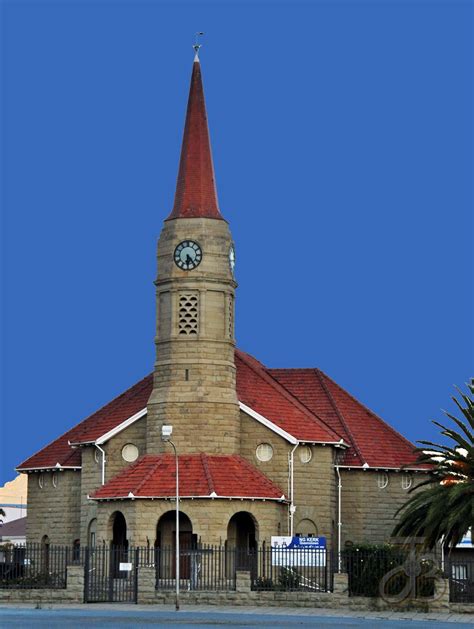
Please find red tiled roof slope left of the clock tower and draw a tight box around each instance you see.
[17,374,153,471]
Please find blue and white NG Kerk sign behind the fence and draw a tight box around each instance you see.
[272,535,326,567]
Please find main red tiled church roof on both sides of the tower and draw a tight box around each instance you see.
[17,350,425,471]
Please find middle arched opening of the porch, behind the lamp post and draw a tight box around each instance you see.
[155,511,197,579]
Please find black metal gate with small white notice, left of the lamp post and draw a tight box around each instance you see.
[84,546,138,603]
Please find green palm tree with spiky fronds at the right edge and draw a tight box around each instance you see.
[393,379,474,548]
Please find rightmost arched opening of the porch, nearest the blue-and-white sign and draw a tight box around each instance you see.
[227,511,257,578]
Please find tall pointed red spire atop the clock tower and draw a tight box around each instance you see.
[167,55,222,220]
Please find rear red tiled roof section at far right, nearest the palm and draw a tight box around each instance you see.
[269,369,425,469]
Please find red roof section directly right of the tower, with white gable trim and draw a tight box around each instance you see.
[235,350,341,444]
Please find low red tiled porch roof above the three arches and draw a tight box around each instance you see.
[91,454,283,500]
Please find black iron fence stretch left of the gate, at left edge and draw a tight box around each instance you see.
[0,544,71,589]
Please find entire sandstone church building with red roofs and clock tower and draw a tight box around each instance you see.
[17,58,423,548]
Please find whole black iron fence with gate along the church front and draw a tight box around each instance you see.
[0,544,474,603]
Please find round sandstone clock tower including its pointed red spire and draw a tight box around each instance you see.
[147,58,240,454]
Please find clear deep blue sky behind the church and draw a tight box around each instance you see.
[0,0,474,482]
